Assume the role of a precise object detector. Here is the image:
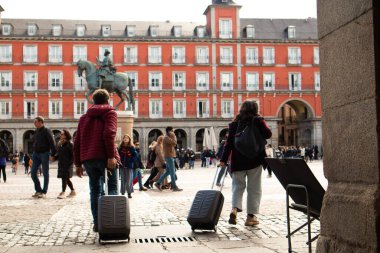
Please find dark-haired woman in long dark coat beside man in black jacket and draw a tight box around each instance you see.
[55,129,76,199]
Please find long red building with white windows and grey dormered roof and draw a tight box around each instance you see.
[0,0,322,157]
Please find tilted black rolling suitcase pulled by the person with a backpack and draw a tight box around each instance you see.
[187,165,226,232]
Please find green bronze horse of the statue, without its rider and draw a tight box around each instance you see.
[77,60,135,110]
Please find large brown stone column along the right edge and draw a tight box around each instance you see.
[317,0,380,253]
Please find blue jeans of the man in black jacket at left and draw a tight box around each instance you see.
[30,152,49,194]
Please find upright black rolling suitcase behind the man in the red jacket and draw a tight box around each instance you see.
[98,169,131,244]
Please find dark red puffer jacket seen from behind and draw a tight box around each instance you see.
[74,104,120,166]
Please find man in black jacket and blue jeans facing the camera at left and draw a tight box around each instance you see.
[30,116,56,198]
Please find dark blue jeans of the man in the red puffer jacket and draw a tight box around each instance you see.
[83,159,117,224]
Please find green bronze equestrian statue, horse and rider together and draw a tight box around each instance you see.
[77,49,135,110]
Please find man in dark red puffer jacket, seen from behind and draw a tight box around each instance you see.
[74,89,120,232]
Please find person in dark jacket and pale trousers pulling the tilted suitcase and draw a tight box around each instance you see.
[219,100,272,226]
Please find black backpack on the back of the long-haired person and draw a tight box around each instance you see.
[234,117,267,159]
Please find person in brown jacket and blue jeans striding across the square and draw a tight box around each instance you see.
[154,126,182,191]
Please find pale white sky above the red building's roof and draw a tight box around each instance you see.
[0,0,317,23]
